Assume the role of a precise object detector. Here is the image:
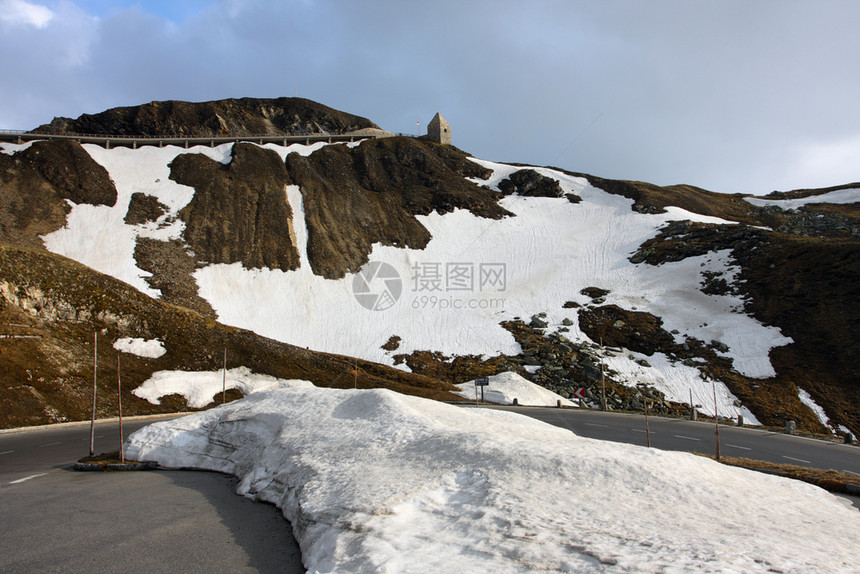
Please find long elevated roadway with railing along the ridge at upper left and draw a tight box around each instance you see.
[0,130,382,149]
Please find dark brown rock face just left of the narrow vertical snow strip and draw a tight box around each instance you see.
[170,144,299,271]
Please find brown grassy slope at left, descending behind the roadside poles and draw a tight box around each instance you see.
[0,244,455,428]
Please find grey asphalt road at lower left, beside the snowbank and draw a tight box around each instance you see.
[0,421,305,574]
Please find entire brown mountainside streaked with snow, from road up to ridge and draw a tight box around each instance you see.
[0,98,860,433]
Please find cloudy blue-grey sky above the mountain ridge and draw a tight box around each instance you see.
[0,0,860,194]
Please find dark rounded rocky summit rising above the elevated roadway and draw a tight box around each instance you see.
[34,98,378,137]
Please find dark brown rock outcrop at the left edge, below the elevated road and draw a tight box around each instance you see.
[0,141,116,247]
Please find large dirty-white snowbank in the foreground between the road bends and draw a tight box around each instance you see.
[126,388,860,574]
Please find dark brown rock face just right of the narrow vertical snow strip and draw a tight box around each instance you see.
[286,138,510,279]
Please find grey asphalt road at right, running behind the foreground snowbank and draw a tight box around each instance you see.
[487,407,860,480]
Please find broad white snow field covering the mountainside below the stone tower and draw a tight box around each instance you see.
[35,143,790,420]
